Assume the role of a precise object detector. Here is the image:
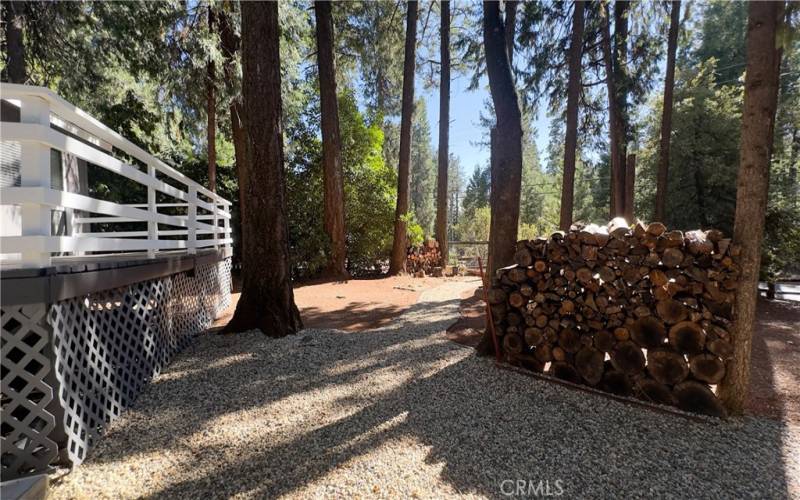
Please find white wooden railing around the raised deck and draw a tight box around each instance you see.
[0,83,232,267]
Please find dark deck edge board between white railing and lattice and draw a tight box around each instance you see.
[0,249,231,306]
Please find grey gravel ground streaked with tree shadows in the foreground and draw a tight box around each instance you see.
[52,281,800,499]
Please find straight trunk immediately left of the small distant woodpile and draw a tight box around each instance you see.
[389,0,417,275]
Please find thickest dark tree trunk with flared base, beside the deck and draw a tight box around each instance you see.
[223,2,303,337]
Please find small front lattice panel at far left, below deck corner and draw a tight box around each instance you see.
[0,304,58,480]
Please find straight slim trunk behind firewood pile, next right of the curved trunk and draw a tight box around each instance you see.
[559,1,586,231]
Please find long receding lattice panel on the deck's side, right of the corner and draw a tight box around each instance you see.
[50,259,230,464]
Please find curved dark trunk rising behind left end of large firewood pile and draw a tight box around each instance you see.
[483,1,522,276]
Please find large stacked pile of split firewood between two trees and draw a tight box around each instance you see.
[489,218,739,416]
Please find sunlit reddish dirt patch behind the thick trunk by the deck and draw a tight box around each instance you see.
[214,276,448,331]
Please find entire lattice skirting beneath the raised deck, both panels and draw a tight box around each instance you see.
[0,258,231,481]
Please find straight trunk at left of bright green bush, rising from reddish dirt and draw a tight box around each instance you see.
[314,2,350,279]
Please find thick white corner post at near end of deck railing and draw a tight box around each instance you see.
[20,96,52,267]
